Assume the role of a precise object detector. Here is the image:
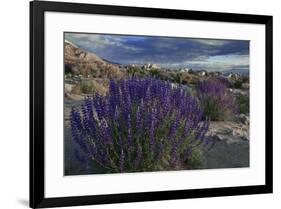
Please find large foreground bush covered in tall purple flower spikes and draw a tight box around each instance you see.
[71,78,209,173]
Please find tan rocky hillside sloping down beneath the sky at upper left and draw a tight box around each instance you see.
[64,41,122,79]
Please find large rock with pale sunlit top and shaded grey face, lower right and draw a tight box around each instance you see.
[199,121,249,169]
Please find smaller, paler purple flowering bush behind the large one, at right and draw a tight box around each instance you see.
[197,77,238,121]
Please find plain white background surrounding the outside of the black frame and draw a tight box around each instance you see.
[0,0,281,209]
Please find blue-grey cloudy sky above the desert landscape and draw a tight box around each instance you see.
[65,33,250,71]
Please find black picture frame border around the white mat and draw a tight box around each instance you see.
[30,1,273,208]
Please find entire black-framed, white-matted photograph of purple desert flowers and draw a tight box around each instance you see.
[30,1,273,208]
